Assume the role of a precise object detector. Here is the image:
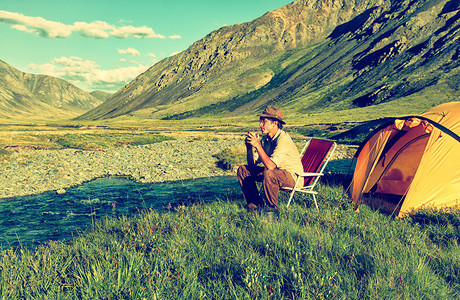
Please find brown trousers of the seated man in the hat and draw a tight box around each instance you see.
[237,165,295,209]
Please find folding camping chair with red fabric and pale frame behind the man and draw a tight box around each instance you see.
[281,138,337,211]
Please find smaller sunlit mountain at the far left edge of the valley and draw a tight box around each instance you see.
[0,60,102,119]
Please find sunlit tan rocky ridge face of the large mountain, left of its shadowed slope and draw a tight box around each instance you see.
[81,0,398,119]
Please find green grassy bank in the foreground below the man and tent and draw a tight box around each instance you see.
[0,184,460,299]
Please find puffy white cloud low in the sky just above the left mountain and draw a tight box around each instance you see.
[28,56,148,91]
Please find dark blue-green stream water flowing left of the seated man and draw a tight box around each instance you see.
[0,177,240,249]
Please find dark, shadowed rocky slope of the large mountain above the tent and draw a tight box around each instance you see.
[225,1,459,118]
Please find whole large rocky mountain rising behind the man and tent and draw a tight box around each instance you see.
[79,0,460,119]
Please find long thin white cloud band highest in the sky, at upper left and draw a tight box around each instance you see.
[0,10,168,39]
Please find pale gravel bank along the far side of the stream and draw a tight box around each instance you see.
[0,139,241,198]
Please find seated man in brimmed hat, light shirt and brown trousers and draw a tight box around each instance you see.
[237,105,303,213]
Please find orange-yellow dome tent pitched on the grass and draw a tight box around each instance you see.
[351,102,460,217]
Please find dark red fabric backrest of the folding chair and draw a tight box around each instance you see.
[301,139,336,186]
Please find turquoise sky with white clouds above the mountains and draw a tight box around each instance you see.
[0,0,293,92]
